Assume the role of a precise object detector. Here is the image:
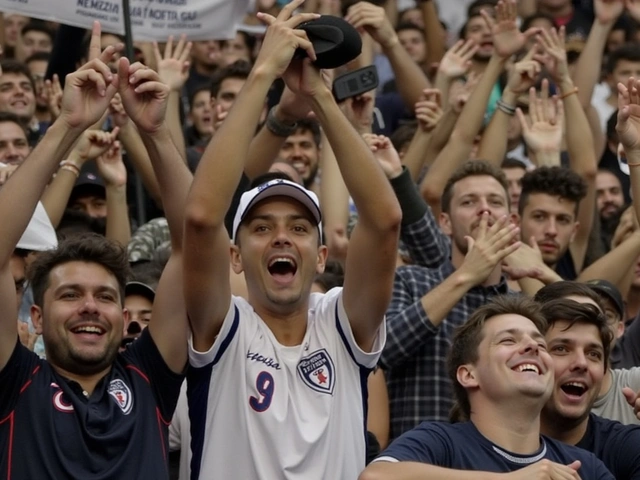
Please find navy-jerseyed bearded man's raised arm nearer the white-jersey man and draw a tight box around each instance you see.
[118,58,193,372]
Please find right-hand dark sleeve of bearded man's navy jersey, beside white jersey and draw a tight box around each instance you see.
[122,329,184,422]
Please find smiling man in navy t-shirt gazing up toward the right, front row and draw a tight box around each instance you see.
[359,296,614,480]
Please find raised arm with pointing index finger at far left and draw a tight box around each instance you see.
[0,22,117,369]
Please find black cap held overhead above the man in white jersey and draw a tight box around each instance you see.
[295,15,362,68]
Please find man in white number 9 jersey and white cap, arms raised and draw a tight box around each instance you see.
[184,0,401,480]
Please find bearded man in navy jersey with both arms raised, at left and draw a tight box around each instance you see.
[0,22,188,479]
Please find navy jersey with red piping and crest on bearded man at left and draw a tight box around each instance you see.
[0,329,184,480]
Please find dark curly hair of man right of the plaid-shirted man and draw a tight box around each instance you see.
[518,167,587,215]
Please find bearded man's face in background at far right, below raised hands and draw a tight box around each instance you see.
[596,168,625,250]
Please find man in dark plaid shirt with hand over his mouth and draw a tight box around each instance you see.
[380,161,520,438]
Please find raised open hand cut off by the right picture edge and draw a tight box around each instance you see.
[616,77,640,152]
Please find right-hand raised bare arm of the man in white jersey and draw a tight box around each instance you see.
[285,66,401,351]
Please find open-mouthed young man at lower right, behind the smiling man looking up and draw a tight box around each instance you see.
[540,295,640,480]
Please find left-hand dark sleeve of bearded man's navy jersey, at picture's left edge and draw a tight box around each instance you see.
[0,336,40,422]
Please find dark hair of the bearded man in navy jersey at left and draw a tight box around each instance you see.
[28,233,129,307]
